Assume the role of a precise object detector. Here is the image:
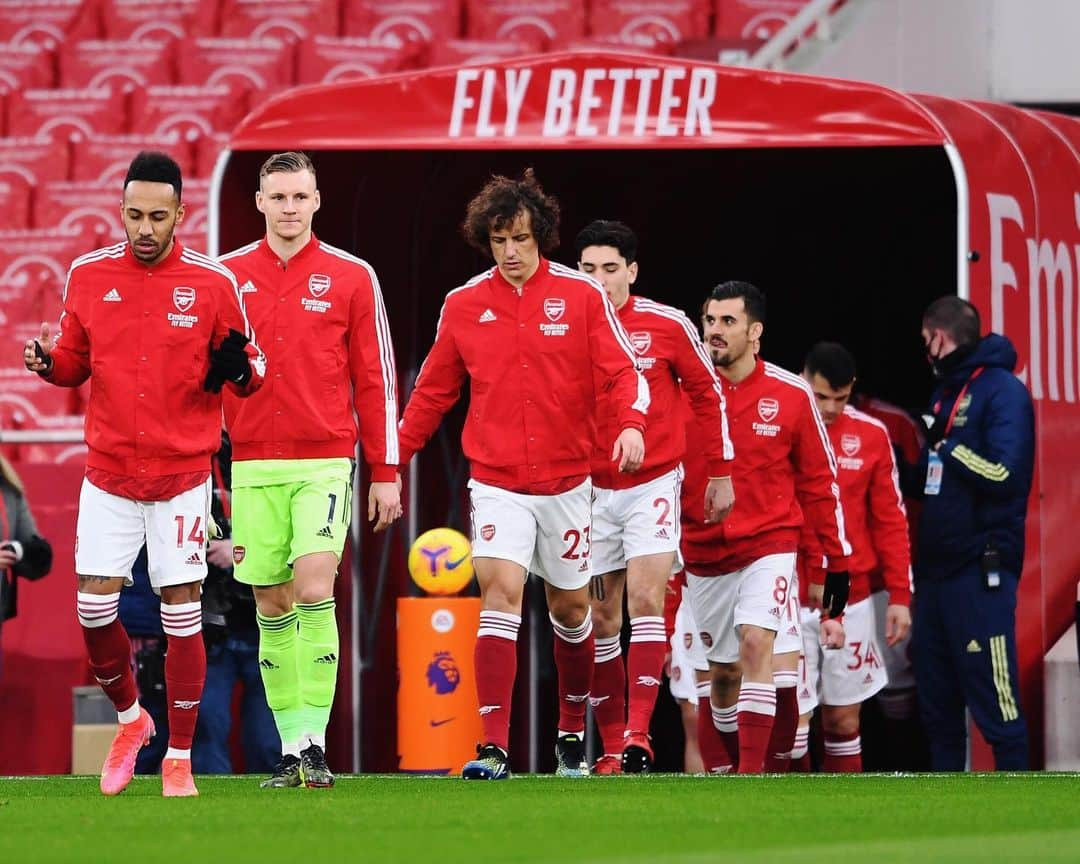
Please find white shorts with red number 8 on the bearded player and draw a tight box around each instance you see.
[686,552,798,663]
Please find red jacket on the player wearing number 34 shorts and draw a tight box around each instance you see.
[799,405,912,606]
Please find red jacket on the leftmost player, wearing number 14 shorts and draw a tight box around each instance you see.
[46,240,266,481]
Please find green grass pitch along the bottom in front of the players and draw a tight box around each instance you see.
[0,773,1080,864]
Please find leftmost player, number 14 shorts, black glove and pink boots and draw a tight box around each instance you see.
[24,152,266,796]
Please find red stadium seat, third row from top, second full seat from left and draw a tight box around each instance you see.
[132,84,247,141]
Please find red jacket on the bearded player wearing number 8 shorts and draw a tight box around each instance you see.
[683,360,851,576]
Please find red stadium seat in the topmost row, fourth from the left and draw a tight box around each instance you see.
[343,0,461,45]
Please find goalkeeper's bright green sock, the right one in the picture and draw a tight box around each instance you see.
[293,597,338,747]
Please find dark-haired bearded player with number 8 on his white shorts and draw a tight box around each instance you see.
[683,282,851,773]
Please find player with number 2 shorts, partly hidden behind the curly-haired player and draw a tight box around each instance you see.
[577,220,734,773]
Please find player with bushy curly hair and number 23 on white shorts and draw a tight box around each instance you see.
[401,170,649,780]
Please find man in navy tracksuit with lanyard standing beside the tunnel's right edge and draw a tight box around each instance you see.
[912,297,1035,771]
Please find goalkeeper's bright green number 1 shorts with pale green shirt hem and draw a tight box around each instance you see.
[232,459,354,585]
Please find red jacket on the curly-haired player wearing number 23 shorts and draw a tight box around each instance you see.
[400,258,649,495]
